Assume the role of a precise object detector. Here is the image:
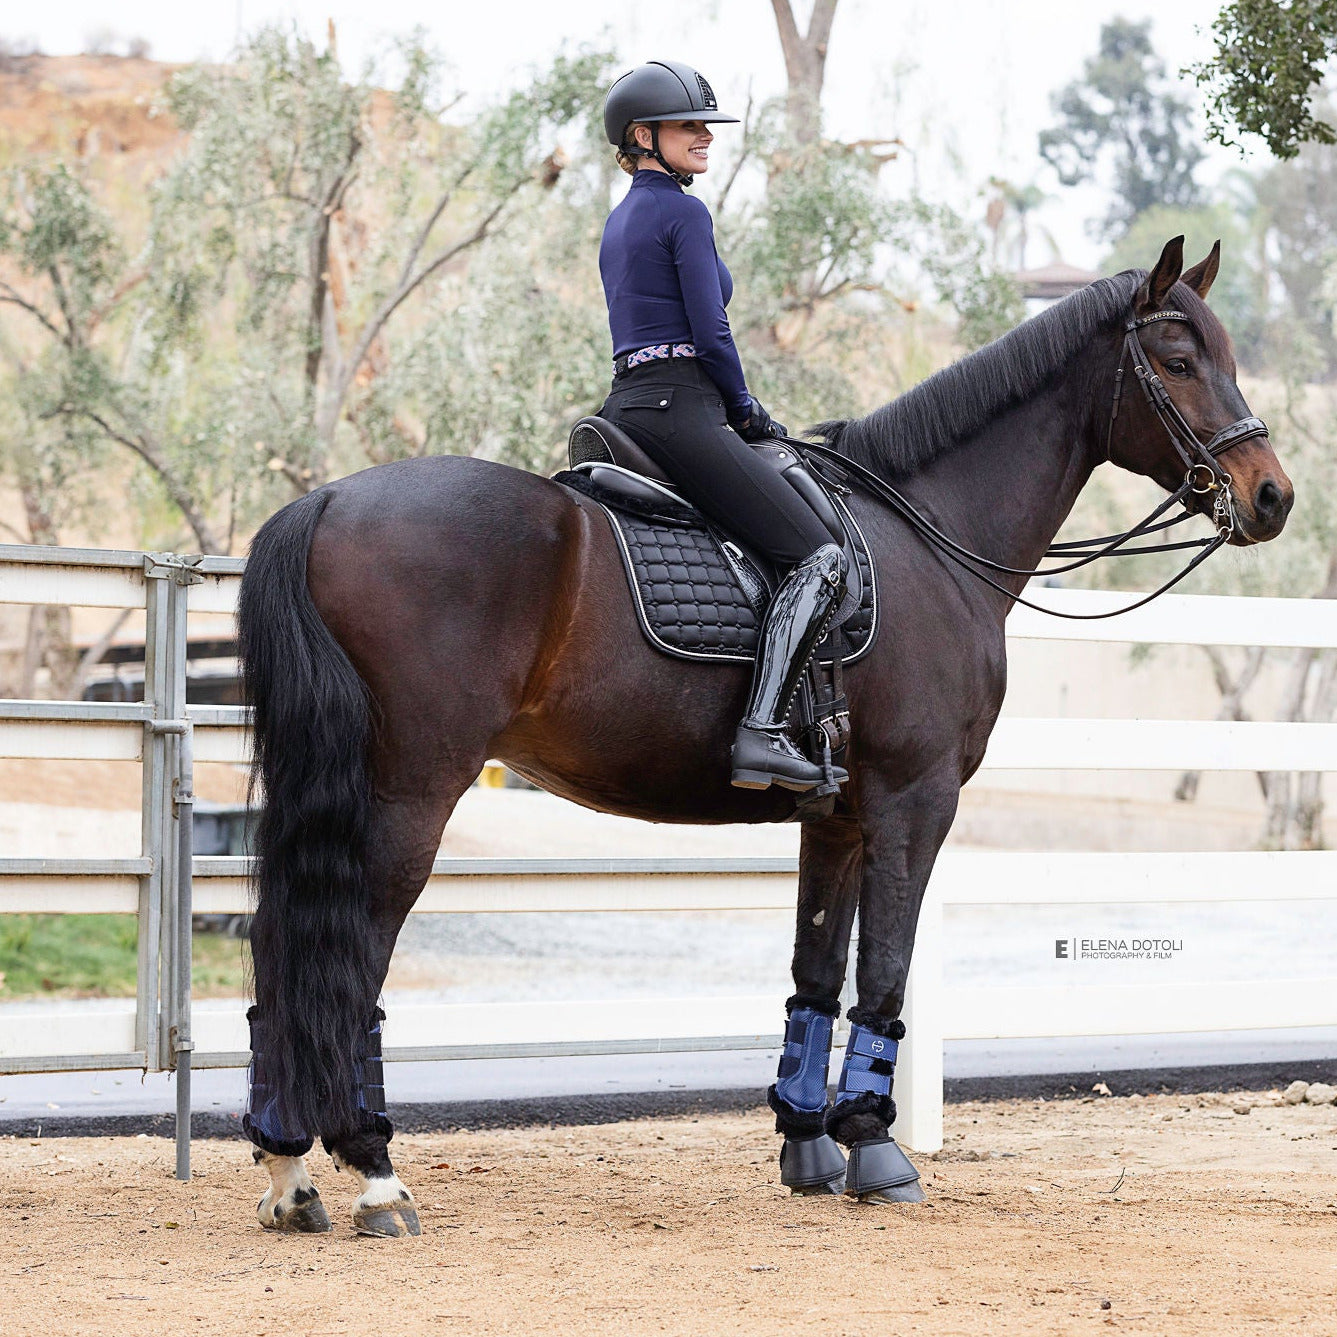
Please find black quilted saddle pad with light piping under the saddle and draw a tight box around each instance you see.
[556,473,877,663]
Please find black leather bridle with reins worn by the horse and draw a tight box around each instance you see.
[782,309,1267,622]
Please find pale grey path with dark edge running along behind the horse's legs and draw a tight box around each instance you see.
[0,1027,1337,1136]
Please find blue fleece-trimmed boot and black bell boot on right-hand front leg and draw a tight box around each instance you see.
[826,1008,924,1202]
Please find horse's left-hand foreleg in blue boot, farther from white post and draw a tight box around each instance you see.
[767,818,861,1194]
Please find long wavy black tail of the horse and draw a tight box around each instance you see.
[238,489,380,1136]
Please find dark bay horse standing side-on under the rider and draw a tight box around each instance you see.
[239,238,1294,1235]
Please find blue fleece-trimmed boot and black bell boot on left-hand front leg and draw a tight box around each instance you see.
[766,995,845,1194]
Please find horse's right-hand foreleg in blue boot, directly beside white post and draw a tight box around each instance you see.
[826,773,960,1202]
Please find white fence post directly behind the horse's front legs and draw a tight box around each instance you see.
[892,878,943,1152]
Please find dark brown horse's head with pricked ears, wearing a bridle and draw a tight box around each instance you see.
[1108,237,1296,545]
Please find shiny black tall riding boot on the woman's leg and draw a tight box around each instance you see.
[733,543,849,790]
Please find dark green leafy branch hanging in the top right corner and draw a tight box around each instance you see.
[1191,0,1337,158]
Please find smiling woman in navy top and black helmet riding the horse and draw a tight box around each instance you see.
[599,60,846,790]
